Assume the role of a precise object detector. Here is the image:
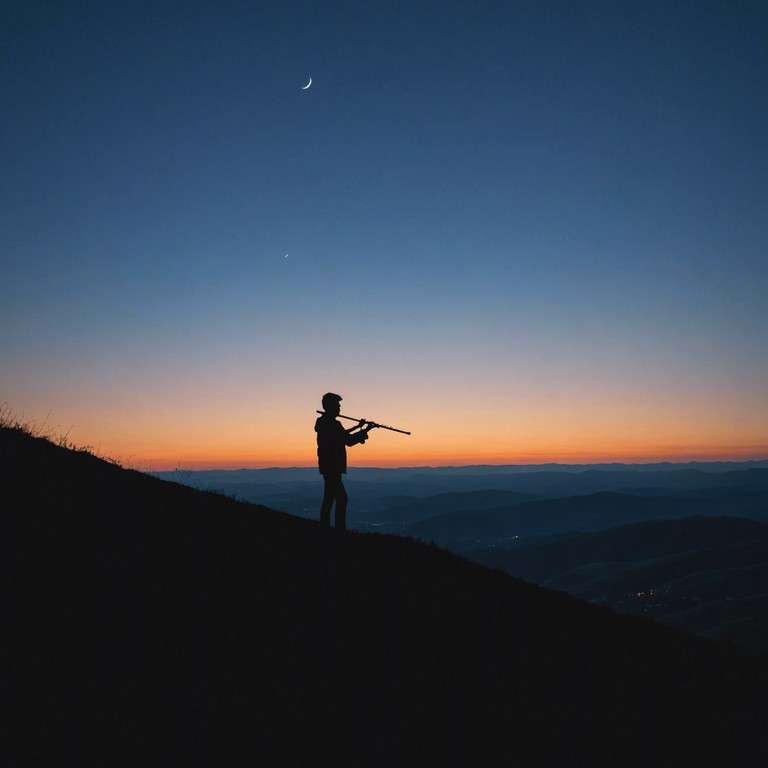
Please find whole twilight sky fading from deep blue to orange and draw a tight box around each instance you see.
[0,0,768,470]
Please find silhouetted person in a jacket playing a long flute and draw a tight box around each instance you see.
[315,392,373,531]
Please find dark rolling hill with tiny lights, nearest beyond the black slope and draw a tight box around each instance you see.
[470,516,768,652]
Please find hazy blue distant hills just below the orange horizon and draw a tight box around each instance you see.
[154,462,768,529]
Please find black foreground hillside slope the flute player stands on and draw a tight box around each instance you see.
[0,429,768,768]
